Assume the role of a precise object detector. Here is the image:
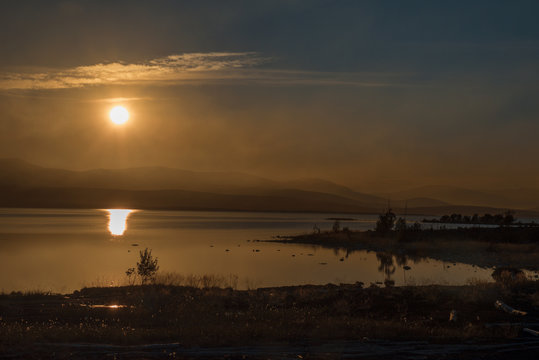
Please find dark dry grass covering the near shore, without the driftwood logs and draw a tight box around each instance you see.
[0,275,539,346]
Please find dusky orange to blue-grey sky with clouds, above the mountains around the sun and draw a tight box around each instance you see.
[0,0,539,191]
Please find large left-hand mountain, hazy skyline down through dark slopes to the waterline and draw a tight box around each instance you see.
[0,159,381,213]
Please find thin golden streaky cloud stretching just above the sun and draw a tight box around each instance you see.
[0,52,411,90]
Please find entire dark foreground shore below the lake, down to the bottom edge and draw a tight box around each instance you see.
[0,281,539,359]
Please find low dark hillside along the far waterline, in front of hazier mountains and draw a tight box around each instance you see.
[0,187,380,213]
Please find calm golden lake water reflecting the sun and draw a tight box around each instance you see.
[0,209,504,292]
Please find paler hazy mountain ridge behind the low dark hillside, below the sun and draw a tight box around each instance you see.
[0,159,386,202]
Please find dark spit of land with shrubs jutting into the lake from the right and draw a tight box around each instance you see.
[264,227,539,271]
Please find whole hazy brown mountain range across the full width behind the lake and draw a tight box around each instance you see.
[0,159,539,214]
